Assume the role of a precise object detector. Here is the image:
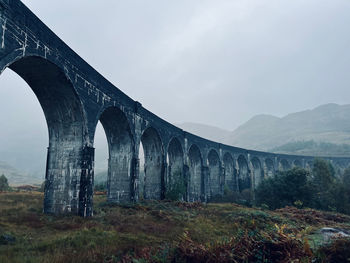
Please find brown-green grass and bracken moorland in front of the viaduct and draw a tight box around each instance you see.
[0,192,350,262]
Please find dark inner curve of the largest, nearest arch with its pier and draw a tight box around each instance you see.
[3,56,87,216]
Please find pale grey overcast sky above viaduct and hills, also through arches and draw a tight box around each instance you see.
[0,0,350,175]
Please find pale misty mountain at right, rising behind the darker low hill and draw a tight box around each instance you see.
[227,104,350,151]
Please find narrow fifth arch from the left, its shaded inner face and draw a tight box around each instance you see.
[188,144,204,202]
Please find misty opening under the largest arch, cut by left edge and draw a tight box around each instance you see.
[0,69,49,186]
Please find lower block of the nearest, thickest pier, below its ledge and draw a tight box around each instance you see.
[44,144,95,217]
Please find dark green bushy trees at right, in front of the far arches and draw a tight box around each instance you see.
[255,159,350,217]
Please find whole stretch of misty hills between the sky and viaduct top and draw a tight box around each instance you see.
[179,104,350,155]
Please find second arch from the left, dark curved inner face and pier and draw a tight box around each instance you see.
[99,107,134,203]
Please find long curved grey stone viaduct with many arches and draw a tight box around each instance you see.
[0,0,350,216]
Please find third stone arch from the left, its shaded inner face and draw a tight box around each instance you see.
[140,127,165,199]
